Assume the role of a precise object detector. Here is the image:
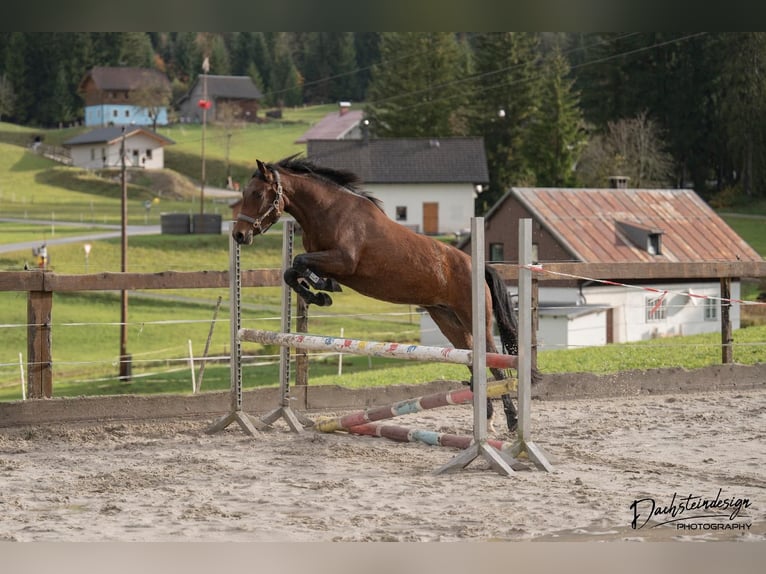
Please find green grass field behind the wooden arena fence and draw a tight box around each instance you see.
[0,105,766,400]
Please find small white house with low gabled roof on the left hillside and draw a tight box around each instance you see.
[63,126,175,169]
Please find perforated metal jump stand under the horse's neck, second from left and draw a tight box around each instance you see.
[261,220,314,433]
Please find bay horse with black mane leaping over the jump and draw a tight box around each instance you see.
[232,154,518,431]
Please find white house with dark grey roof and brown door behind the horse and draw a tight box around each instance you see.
[306,137,489,234]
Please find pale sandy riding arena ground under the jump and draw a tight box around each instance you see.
[0,390,766,542]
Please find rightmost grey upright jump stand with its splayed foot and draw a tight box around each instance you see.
[510,219,553,472]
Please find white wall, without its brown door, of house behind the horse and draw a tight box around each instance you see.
[364,183,474,234]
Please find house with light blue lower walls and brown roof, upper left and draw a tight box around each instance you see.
[78,66,171,126]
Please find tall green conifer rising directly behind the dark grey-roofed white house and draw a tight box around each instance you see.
[366,32,466,137]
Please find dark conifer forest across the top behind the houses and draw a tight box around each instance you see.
[0,32,766,212]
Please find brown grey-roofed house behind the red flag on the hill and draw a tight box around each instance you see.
[177,74,263,123]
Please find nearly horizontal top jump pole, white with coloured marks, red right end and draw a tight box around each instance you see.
[239,329,517,369]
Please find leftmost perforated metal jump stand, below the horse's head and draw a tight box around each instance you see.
[206,234,266,436]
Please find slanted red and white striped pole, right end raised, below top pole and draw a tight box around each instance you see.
[314,379,516,434]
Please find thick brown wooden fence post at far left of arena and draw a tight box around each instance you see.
[27,291,53,399]
